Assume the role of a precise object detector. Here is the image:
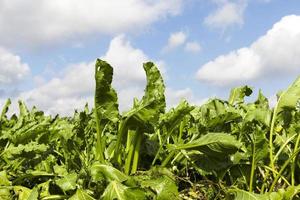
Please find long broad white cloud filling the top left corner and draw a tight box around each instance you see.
[0,0,182,45]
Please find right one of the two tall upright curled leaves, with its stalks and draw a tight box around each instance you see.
[114,62,166,166]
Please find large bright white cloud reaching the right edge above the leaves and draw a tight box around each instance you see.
[197,15,300,85]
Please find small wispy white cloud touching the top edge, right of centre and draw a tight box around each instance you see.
[204,0,247,31]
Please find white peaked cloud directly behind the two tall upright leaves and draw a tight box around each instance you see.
[15,35,164,115]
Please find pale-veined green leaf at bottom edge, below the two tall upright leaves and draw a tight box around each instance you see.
[101,181,146,200]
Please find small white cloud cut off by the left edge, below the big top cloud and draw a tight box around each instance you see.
[0,47,30,85]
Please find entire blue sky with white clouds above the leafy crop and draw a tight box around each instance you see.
[0,0,300,115]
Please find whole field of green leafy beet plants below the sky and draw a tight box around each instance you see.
[0,60,300,200]
